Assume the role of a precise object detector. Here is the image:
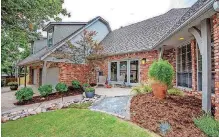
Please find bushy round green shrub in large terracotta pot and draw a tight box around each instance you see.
[148,60,174,99]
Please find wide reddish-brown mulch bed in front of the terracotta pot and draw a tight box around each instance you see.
[131,94,205,137]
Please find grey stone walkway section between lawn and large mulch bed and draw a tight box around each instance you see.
[90,96,132,120]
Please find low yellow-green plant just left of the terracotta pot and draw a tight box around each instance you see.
[131,84,152,94]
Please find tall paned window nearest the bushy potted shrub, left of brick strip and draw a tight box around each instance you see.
[177,44,192,88]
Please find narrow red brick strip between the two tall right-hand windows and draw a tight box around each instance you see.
[191,40,197,91]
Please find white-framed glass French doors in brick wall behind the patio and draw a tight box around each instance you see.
[108,60,139,85]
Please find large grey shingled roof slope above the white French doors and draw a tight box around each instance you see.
[101,8,188,55]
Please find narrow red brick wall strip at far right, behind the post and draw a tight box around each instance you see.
[213,13,219,120]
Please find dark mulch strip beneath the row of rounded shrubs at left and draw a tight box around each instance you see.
[14,87,83,105]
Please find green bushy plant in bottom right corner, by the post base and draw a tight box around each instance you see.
[194,114,219,137]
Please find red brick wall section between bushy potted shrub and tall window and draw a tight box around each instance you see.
[163,48,176,85]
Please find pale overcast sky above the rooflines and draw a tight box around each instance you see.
[62,0,197,30]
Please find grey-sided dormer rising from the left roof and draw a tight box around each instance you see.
[43,22,87,47]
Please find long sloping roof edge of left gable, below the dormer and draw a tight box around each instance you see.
[17,16,111,66]
